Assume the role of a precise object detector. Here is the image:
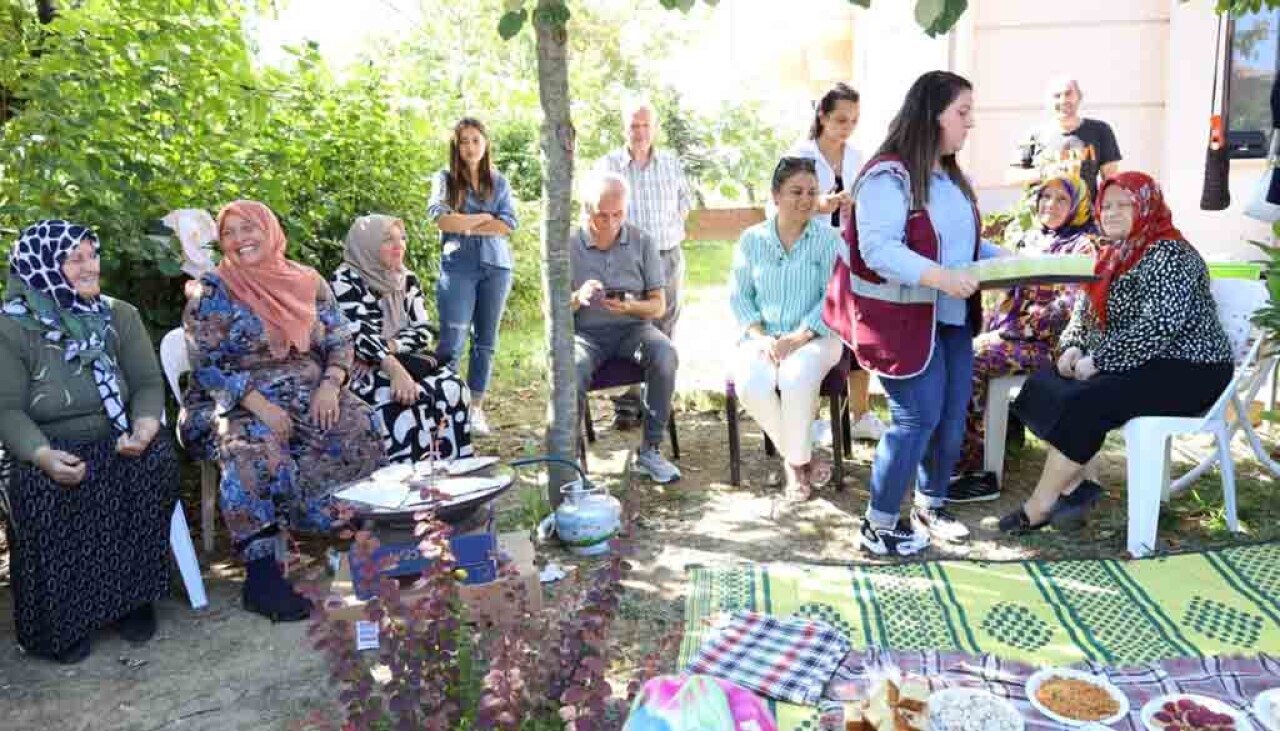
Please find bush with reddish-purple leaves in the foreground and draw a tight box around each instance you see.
[296,481,680,731]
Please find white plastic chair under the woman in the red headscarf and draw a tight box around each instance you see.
[1124,279,1280,558]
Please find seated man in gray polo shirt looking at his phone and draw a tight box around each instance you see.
[570,173,680,483]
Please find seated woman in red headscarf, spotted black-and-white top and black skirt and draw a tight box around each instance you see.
[1000,173,1233,533]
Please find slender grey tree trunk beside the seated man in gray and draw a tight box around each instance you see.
[534,0,577,506]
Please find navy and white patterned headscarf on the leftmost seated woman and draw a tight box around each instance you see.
[4,220,129,434]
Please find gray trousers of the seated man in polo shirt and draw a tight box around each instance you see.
[573,321,680,446]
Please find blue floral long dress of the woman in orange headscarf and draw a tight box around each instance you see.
[180,274,387,561]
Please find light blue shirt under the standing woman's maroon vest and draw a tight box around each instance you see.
[855,170,1002,325]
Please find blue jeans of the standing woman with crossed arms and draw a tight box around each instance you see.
[435,260,511,398]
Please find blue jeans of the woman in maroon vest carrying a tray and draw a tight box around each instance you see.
[867,323,973,526]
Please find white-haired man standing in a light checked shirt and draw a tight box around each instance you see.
[594,97,694,429]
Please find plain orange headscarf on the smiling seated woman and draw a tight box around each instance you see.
[216,201,320,357]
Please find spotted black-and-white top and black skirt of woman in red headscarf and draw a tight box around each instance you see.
[1012,239,1234,465]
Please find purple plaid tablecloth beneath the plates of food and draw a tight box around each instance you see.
[819,649,1280,731]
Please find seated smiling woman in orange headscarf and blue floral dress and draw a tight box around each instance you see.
[182,201,387,621]
